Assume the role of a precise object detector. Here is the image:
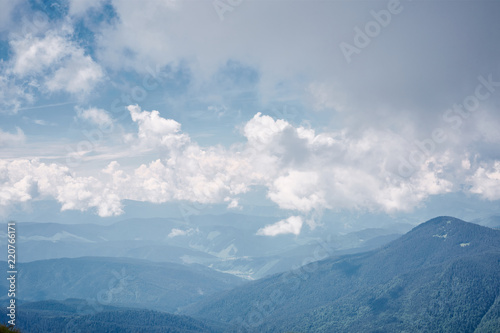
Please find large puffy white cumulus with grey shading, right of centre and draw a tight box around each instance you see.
[245,114,452,213]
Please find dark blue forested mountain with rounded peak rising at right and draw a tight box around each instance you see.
[183,217,500,332]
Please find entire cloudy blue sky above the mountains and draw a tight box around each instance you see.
[0,0,500,233]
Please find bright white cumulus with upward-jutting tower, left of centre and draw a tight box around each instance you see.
[97,106,252,207]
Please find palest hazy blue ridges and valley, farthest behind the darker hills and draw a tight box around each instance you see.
[0,214,411,279]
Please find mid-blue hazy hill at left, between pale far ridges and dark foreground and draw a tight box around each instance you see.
[0,257,244,312]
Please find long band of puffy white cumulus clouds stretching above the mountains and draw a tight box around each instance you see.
[0,106,478,226]
